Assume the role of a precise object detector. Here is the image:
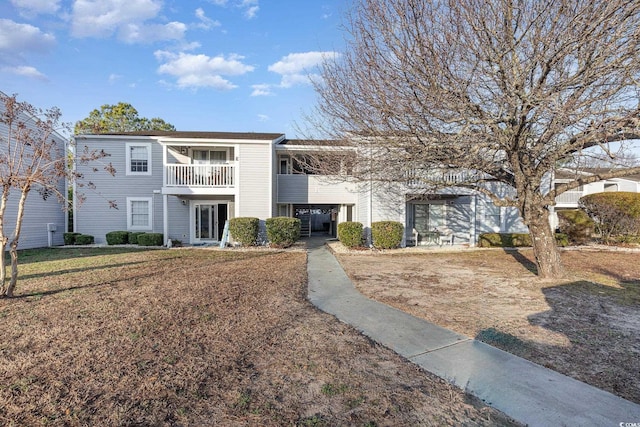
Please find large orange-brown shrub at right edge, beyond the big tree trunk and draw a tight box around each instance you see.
[578,191,640,242]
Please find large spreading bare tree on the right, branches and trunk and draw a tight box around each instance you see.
[310,0,640,277]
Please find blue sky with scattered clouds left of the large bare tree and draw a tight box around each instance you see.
[0,0,349,137]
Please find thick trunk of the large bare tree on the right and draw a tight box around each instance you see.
[523,207,565,279]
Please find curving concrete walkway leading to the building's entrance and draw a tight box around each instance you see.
[307,237,640,427]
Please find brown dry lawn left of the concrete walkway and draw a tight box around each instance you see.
[0,249,512,426]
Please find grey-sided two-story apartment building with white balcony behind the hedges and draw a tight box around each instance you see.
[74,131,526,245]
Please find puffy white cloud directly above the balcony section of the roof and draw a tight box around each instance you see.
[155,51,254,90]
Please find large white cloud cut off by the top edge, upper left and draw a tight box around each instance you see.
[71,0,187,43]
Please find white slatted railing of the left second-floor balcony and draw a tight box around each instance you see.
[165,162,236,188]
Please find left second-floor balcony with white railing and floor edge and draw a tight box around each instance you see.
[163,162,237,194]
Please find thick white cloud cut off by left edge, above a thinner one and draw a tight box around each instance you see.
[0,19,56,57]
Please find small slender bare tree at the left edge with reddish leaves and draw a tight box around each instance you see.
[0,92,115,297]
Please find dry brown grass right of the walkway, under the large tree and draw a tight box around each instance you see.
[338,249,640,403]
